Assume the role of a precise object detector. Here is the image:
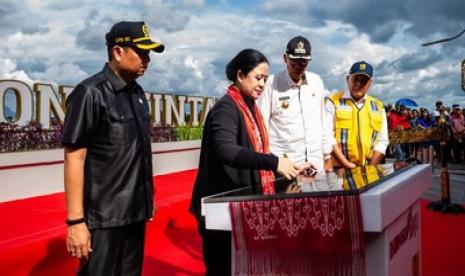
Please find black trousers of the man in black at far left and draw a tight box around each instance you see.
[77,221,145,276]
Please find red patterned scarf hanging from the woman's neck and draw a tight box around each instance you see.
[227,85,275,195]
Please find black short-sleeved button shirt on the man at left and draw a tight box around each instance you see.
[62,64,153,229]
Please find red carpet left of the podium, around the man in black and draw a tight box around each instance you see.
[0,170,205,276]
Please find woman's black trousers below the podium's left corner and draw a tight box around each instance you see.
[197,220,231,276]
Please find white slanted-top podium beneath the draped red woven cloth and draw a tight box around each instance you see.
[202,164,432,276]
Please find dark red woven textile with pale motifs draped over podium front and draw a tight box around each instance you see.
[229,195,366,276]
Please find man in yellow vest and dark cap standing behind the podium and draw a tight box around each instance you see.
[325,61,389,168]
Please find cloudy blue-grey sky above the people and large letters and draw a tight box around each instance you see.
[0,0,465,108]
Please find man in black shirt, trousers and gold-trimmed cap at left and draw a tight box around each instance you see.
[62,21,164,276]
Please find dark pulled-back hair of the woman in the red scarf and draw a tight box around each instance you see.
[226,49,269,82]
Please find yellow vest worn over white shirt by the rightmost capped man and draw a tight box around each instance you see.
[328,92,384,166]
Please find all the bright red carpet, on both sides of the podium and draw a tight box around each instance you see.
[0,170,465,276]
